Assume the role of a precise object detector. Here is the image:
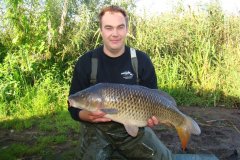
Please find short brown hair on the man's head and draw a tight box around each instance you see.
[98,5,128,27]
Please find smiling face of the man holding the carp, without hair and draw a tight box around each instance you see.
[101,12,128,52]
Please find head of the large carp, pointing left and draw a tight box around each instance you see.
[68,89,102,111]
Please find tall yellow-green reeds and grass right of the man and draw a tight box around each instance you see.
[128,1,240,107]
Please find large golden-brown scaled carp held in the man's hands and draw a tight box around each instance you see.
[68,83,201,150]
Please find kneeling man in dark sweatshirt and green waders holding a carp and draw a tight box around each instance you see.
[69,6,172,160]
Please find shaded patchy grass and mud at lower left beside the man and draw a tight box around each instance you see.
[0,111,79,160]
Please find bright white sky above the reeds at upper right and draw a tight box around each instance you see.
[136,0,240,15]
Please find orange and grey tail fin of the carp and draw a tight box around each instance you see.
[176,116,201,151]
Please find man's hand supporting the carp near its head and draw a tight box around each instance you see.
[79,110,111,123]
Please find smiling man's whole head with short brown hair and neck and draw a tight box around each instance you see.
[99,6,128,57]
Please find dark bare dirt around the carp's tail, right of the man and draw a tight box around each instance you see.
[154,107,240,160]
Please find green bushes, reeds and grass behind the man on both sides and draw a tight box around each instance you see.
[0,0,240,159]
